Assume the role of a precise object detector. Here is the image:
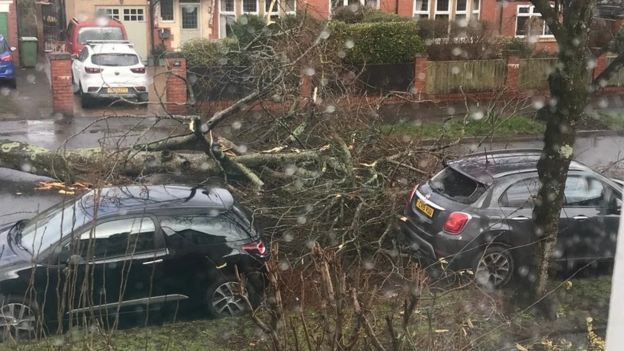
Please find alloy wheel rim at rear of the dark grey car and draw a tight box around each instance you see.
[475,250,513,288]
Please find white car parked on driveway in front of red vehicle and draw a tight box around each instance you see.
[72,40,148,107]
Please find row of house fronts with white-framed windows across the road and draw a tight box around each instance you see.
[62,0,622,57]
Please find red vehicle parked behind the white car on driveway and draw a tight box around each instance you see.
[65,17,128,56]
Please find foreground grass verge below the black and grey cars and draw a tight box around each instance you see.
[0,274,611,351]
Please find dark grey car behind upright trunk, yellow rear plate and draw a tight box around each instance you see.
[402,150,622,287]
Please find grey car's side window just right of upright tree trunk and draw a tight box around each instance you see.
[564,176,606,207]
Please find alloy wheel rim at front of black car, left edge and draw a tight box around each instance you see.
[0,303,36,340]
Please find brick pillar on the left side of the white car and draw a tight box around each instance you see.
[49,53,74,117]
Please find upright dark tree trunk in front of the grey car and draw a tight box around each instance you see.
[533,1,594,301]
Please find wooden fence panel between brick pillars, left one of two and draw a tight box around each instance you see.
[426,60,507,94]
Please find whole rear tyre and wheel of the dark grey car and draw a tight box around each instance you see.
[473,244,515,289]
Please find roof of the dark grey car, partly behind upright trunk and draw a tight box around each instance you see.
[447,149,589,185]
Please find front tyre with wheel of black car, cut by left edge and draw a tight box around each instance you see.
[0,296,39,341]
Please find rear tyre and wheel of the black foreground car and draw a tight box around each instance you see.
[206,276,260,318]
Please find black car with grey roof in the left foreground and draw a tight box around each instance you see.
[0,186,269,337]
